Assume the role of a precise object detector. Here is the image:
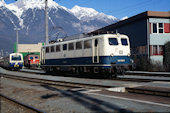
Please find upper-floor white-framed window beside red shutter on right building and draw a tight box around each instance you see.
[152,23,164,33]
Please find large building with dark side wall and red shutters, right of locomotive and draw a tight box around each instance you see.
[89,11,170,64]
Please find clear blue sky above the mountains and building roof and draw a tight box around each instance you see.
[5,0,170,19]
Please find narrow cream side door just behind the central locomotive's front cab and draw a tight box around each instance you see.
[92,39,99,63]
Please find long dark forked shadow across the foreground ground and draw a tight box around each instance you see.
[41,84,132,113]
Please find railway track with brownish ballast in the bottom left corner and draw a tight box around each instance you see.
[0,94,45,113]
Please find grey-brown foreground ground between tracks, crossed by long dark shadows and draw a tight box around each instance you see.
[0,74,170,113]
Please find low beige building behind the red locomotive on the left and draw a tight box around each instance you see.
[14,43,43,57]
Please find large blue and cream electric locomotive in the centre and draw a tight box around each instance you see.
[41,34,132,75]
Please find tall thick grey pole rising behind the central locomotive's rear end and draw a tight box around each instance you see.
[45,0,48,45]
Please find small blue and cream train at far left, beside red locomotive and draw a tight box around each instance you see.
[0,53,23,70]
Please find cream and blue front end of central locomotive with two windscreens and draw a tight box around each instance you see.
[107,34,132,75]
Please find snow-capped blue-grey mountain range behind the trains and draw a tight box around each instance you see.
[0,0,118,51]
